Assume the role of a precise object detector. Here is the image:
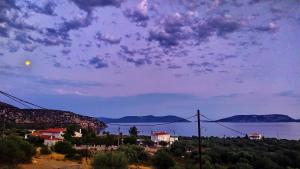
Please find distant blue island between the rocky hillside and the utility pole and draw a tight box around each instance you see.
[98,115,190,123]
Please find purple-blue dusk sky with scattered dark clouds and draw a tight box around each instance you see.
[0,0,300,118]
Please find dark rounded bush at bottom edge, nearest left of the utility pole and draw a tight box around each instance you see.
[153,150,175,169]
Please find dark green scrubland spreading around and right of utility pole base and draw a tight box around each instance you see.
[173,137,300,169]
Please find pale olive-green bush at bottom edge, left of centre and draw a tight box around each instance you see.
[92,152,128,169]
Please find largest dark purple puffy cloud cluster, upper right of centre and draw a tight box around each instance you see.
[148,13,242,48]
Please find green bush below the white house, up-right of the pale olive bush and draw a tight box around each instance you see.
[118,145,149,163]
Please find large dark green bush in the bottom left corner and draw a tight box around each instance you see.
[0,137,35,164]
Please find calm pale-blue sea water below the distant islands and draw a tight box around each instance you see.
[106,122,300,140]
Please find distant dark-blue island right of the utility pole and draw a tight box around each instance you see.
[213,114,300,123]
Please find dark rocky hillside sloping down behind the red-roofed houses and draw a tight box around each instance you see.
[0,102,106,129]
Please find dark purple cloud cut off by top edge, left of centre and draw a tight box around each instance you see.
[70,0,123,13]
